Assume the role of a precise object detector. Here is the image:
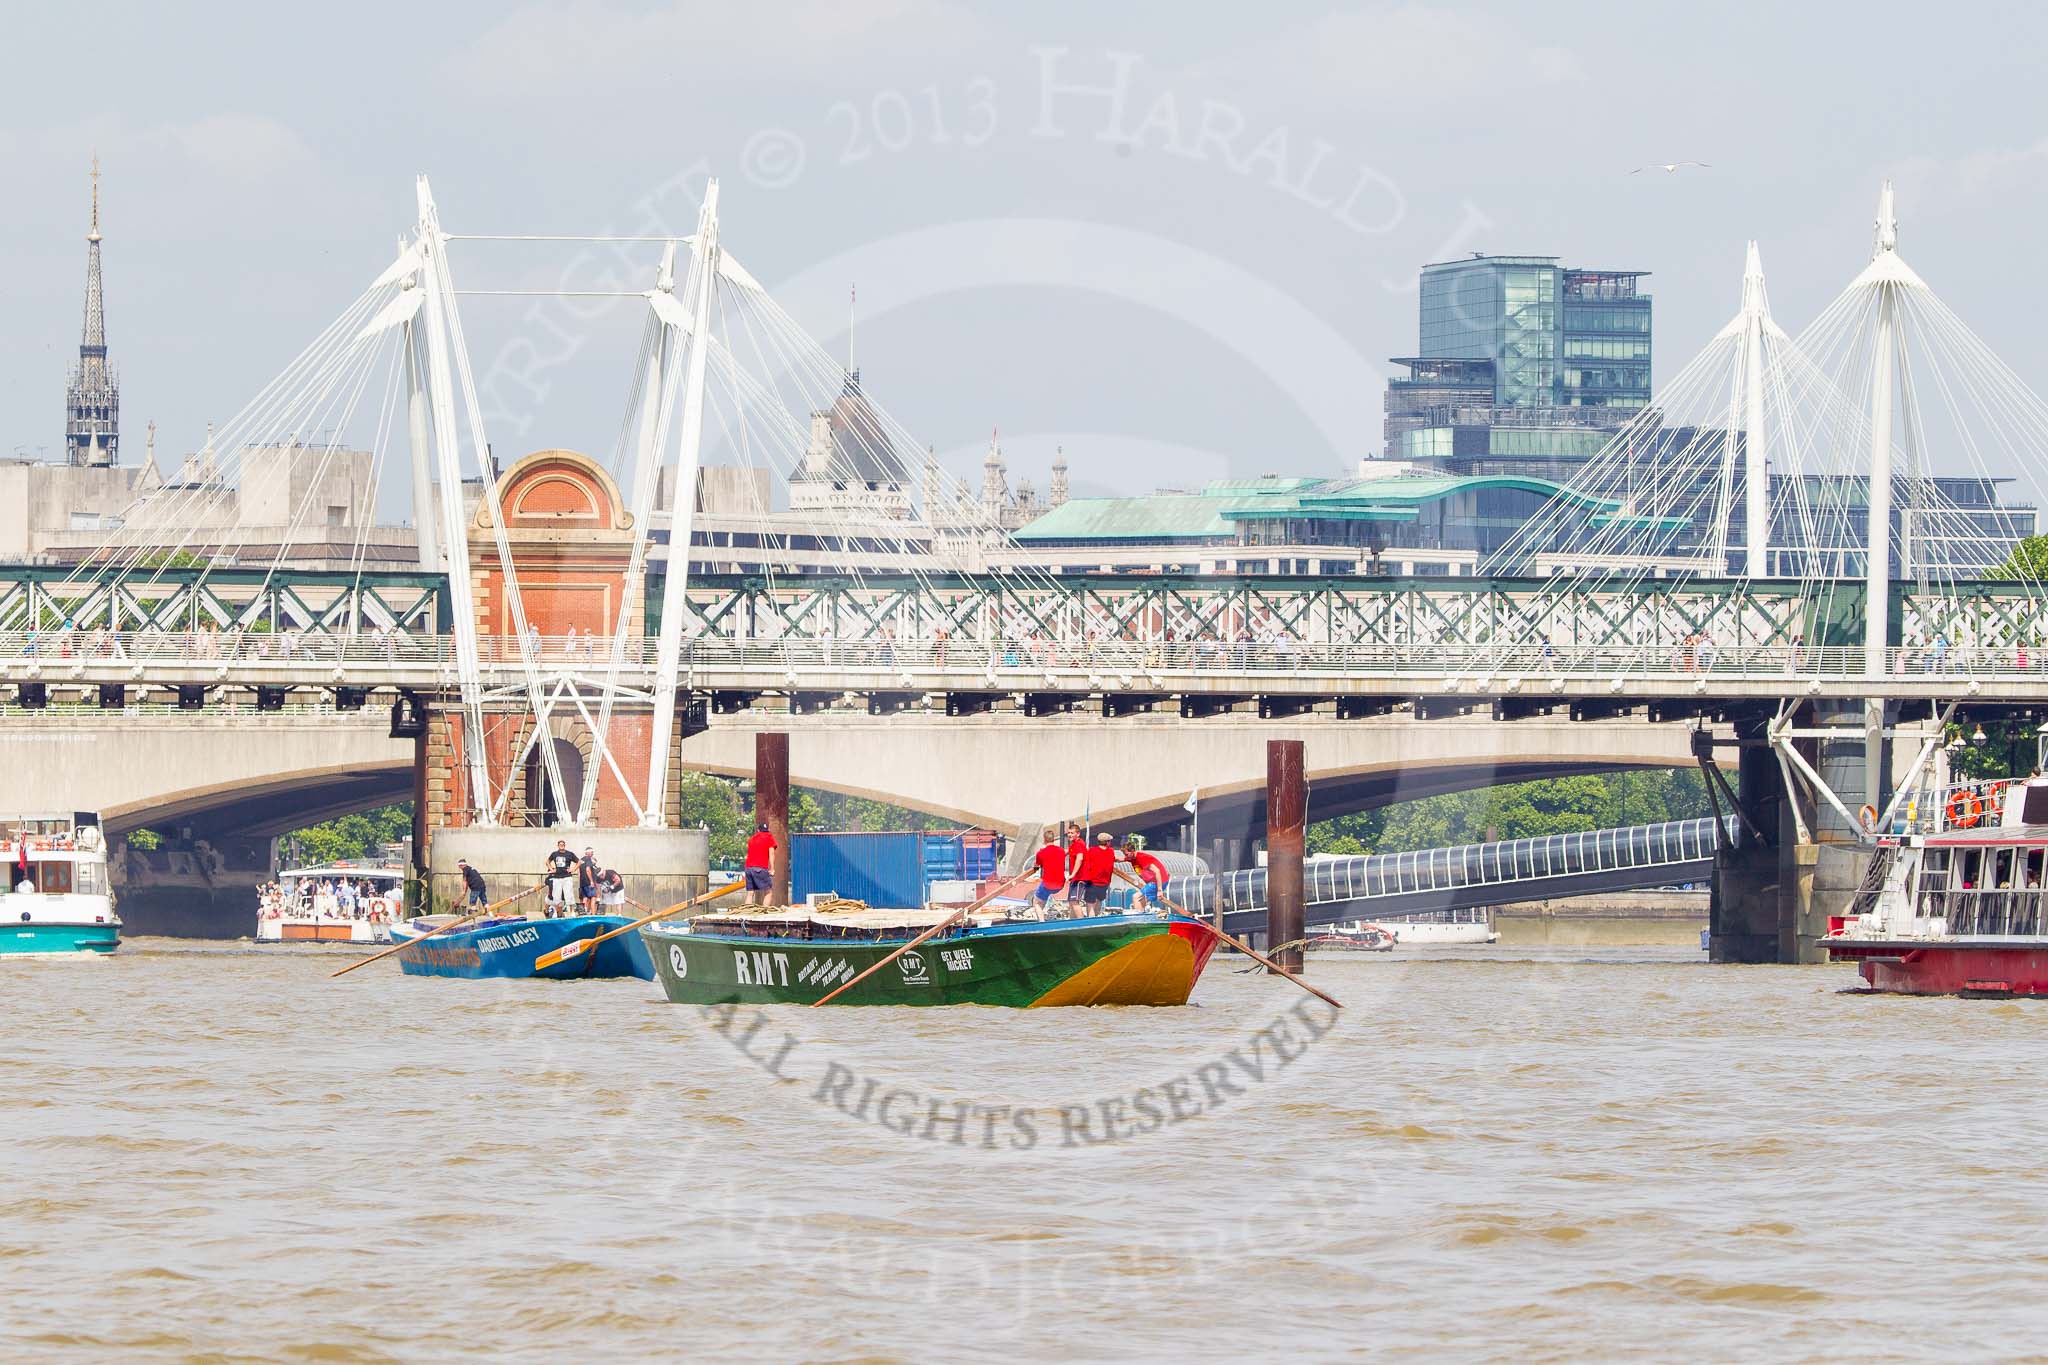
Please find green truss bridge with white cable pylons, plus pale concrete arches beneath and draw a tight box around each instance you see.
[16,180,2048,960]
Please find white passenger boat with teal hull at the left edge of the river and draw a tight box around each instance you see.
[0,810,121,958]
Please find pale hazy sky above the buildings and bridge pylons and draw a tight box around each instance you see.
[0,0,2048,507]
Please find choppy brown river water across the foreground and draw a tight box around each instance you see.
[0,939,2048,1363]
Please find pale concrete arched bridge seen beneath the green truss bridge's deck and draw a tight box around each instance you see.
[0,706,1692,935]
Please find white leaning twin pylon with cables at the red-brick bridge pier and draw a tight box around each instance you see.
[344,176,1047,827]
